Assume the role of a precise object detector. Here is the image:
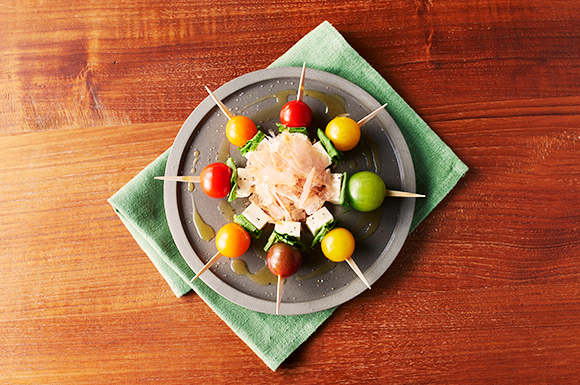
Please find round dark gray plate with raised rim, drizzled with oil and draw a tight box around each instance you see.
[164,67,415,315]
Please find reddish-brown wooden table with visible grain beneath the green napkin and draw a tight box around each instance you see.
[0,0,580,384]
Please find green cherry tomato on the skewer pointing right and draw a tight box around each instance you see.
[348,171,386,212]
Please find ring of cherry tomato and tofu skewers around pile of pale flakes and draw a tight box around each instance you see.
[158,65,421,314]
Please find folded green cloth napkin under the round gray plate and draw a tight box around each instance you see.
[109,22,467,370]
